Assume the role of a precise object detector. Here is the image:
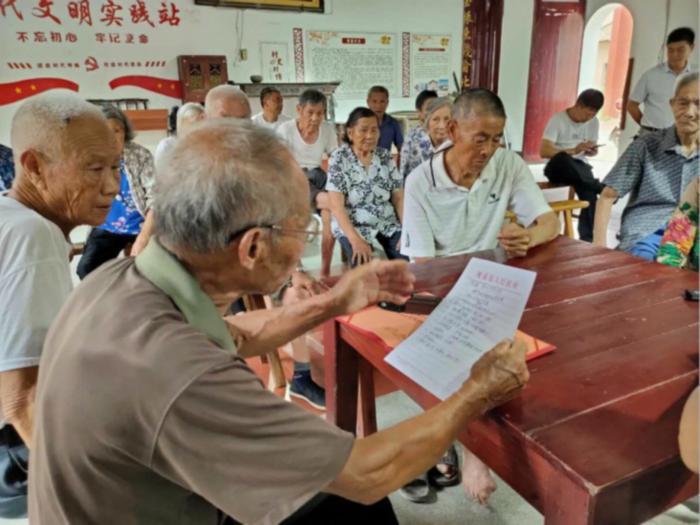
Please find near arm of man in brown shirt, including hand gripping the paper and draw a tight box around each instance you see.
[326,342,528,504]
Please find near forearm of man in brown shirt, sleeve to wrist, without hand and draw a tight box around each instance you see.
[326,381,488,504]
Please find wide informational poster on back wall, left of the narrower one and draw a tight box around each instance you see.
[303,30,400,99]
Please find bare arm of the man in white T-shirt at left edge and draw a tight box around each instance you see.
[0,366,39,448]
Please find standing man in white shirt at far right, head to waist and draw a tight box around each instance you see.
[627,27,695,136]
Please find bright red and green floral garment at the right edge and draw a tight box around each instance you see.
[656,177,700,271]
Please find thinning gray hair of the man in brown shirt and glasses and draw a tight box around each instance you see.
[153,119,303,253]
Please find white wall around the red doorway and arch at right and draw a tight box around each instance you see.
[499,0,699,155]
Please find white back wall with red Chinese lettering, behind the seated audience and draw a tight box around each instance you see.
[0,0,464,143]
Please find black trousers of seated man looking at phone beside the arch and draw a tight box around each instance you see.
[544,151,605,242]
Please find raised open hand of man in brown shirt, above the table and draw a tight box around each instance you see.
[330,261,415,315]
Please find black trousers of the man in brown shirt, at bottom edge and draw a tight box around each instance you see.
[221,494,399,525]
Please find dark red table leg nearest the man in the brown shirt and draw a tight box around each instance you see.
[323,320,358,433]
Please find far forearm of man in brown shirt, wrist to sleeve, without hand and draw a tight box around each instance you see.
[226,292,344,357]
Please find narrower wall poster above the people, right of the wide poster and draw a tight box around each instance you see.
[410,33,452,97]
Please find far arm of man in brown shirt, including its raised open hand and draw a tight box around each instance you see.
[226,261,414,357]
